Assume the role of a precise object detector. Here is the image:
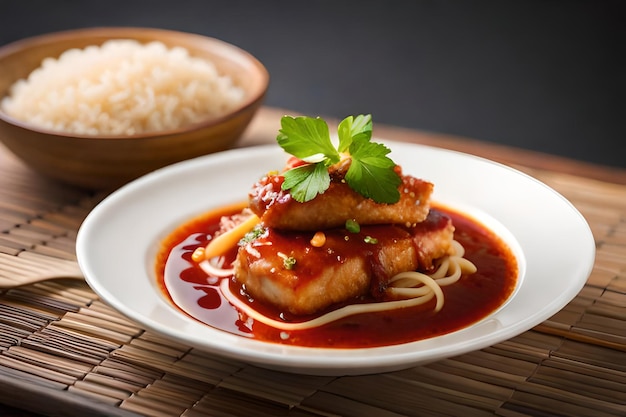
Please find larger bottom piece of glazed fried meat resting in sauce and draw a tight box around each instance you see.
[235,210,454,315]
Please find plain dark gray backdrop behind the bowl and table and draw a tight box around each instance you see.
[0,0,626,167]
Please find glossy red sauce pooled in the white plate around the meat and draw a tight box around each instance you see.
[156,203,517,348]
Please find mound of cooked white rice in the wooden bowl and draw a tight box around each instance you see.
[1,40,244,135]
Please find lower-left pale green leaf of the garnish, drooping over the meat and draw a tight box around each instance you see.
[282,163,330,203]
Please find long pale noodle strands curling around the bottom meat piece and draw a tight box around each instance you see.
[199,241,476,331]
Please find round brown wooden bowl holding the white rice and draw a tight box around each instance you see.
[0,28,269,189]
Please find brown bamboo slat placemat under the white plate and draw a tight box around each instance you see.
[0,137,626,417]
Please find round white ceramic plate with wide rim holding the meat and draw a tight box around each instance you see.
[77,142,595,375]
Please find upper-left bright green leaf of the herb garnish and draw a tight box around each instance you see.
[276,116,339,165]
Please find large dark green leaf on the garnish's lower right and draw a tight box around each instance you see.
[346,138,402,204]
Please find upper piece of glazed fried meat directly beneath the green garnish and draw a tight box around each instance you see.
[249,165,433,231]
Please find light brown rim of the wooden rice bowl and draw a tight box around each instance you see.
[0,26,270,140]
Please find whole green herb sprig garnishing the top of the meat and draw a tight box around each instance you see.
[276,115,401,204]
